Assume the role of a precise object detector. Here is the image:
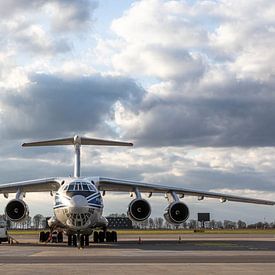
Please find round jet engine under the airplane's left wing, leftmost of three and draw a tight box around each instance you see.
[5,199,29,222]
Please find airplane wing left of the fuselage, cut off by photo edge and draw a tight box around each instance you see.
[0,178,61,194]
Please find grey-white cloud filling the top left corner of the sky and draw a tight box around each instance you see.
[0,0,97,66]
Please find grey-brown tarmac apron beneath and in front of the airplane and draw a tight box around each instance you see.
[0,234,275,275]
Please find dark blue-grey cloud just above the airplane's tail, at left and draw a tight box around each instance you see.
[1,74,144,138]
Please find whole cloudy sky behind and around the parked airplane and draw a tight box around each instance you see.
[0,0,275,223]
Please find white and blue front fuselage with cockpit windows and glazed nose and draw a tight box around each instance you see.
[51,178,108,234]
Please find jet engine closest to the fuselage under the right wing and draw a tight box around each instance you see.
[127,198,151,222]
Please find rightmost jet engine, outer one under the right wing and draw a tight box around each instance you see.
[164,201,189,225]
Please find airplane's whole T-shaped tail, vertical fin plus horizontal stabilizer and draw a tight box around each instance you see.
[22,135,133,178]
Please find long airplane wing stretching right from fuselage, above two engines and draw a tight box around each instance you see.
[98,177,275,205]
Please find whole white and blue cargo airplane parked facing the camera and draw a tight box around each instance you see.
[0,135,275,248]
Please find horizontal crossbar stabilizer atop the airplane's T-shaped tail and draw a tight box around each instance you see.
[22,136,133,147]
